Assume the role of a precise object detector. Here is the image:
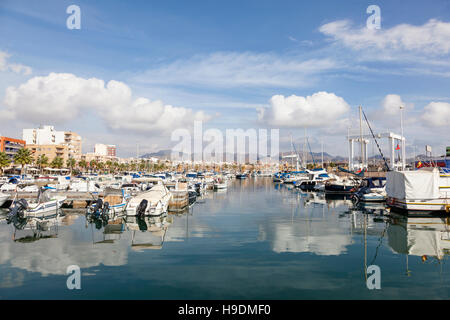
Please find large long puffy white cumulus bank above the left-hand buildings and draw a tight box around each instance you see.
[4,73,208,132]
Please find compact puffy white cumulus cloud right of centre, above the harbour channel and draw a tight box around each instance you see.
[258,91,350,127]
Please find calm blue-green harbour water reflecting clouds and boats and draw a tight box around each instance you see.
[0,178,450,299]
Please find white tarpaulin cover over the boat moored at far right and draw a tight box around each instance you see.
[386,168,440,199]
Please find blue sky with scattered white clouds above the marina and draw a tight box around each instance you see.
[0,0,450,157]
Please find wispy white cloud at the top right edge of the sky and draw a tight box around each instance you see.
[319,19,450,56]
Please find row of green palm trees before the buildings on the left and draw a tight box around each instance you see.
[0,148,168,174]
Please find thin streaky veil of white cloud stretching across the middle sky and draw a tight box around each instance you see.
[133,52,336,88]
